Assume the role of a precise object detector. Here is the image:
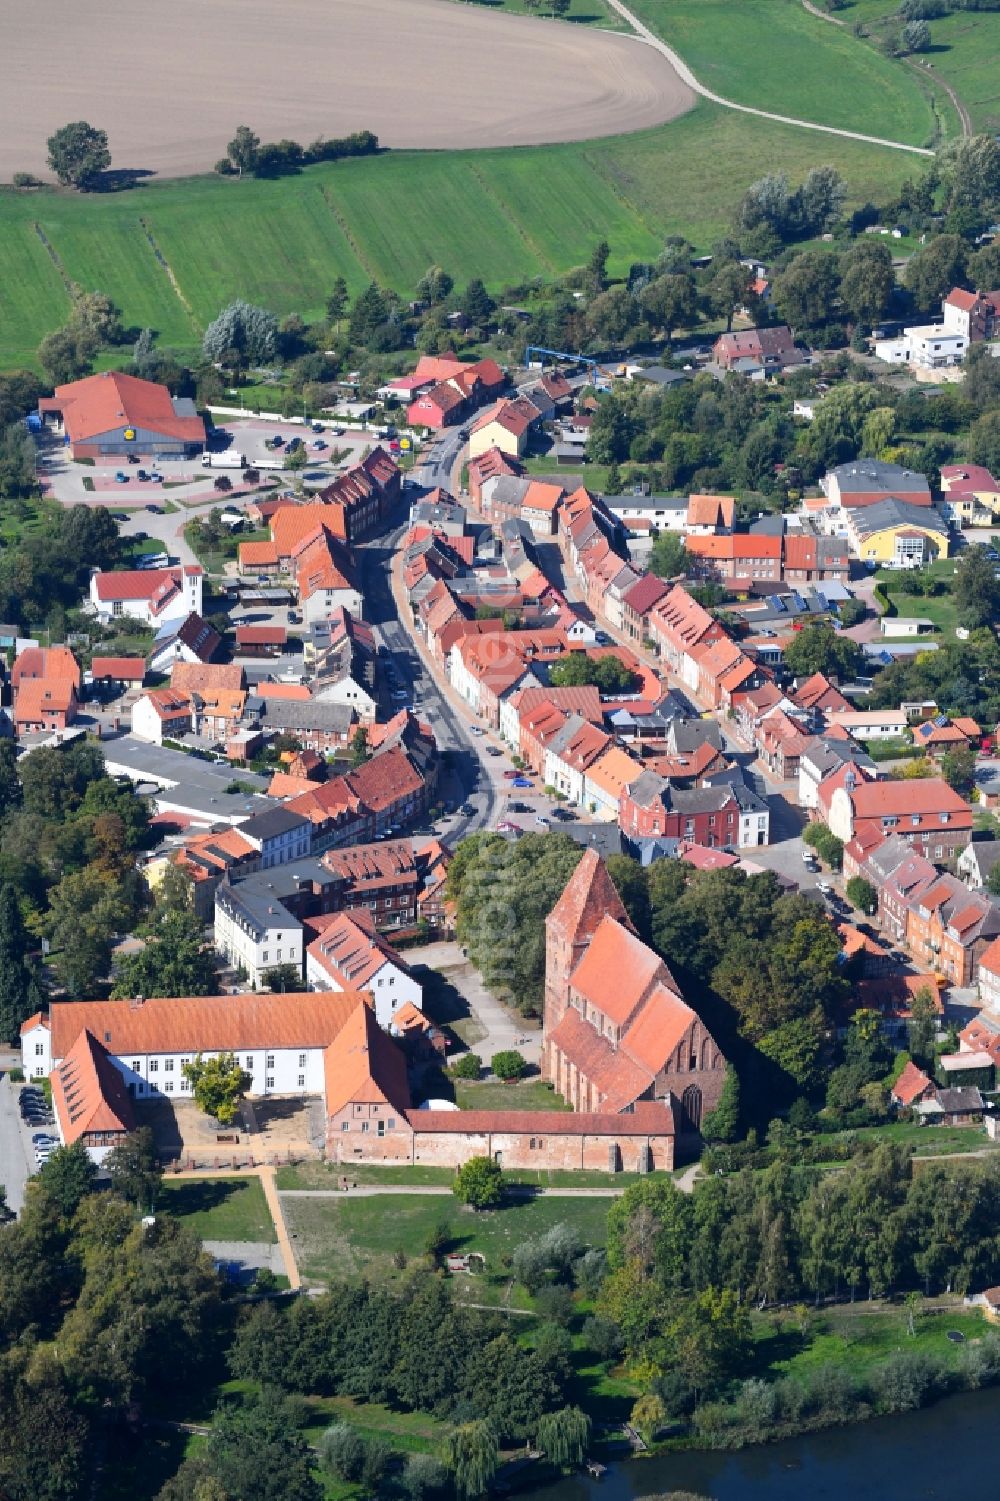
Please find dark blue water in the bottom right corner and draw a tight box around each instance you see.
[520,1388,1000,1501]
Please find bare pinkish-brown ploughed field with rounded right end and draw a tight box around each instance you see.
[0,0,694,180]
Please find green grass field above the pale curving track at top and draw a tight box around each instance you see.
[632,0,942,145]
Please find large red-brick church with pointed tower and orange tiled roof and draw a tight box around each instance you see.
[542,850,725,1133]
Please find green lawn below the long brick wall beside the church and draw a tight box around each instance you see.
[282,1193,608,1306]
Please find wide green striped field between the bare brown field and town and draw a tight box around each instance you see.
[0,101,916,368]
